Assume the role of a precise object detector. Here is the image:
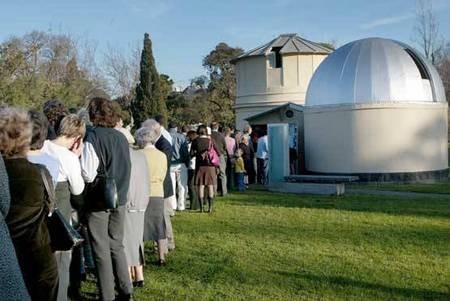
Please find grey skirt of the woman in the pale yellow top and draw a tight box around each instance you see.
[144,197,166,241]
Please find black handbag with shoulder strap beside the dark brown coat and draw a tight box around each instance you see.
[41,169,84,251]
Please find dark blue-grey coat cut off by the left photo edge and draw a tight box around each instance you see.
[0,156,30,301]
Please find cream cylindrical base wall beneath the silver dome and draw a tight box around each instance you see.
[304,103,448,175]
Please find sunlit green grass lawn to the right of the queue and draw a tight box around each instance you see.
[82,191,450,300]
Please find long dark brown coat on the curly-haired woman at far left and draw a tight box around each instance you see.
[5,158,58,300]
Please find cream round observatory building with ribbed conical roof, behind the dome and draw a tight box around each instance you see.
[232,34,331,129]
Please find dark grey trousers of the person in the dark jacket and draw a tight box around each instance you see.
[87,206,133,300]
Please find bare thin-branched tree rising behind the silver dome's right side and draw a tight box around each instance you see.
[414,0,444,64]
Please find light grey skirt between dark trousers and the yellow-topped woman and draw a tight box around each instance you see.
[123,210,145,266]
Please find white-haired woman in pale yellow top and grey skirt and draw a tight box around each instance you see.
[135,126,167,266]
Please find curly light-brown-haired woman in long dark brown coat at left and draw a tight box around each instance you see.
[0,107,58,301]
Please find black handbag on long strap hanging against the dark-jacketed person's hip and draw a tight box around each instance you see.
[86,132,118,211]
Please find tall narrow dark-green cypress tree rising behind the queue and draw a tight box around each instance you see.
[131,33,167,127]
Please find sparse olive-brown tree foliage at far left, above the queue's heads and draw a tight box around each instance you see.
[0,31,106,108]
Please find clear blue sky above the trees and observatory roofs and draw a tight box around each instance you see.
[0,0,450,86]
